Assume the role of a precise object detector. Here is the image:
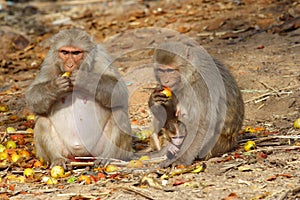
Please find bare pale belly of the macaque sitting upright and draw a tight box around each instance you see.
[50,92,107,157]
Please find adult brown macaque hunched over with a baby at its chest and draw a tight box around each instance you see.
[148,42,244,166]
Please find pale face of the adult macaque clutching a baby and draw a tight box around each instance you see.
[156,65,182,91]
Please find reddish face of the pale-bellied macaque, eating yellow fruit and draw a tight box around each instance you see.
[58,46,84,72]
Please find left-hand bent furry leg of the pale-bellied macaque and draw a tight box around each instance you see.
[34,117,69,168]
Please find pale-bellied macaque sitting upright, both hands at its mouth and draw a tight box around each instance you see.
[25,29,132,168]
